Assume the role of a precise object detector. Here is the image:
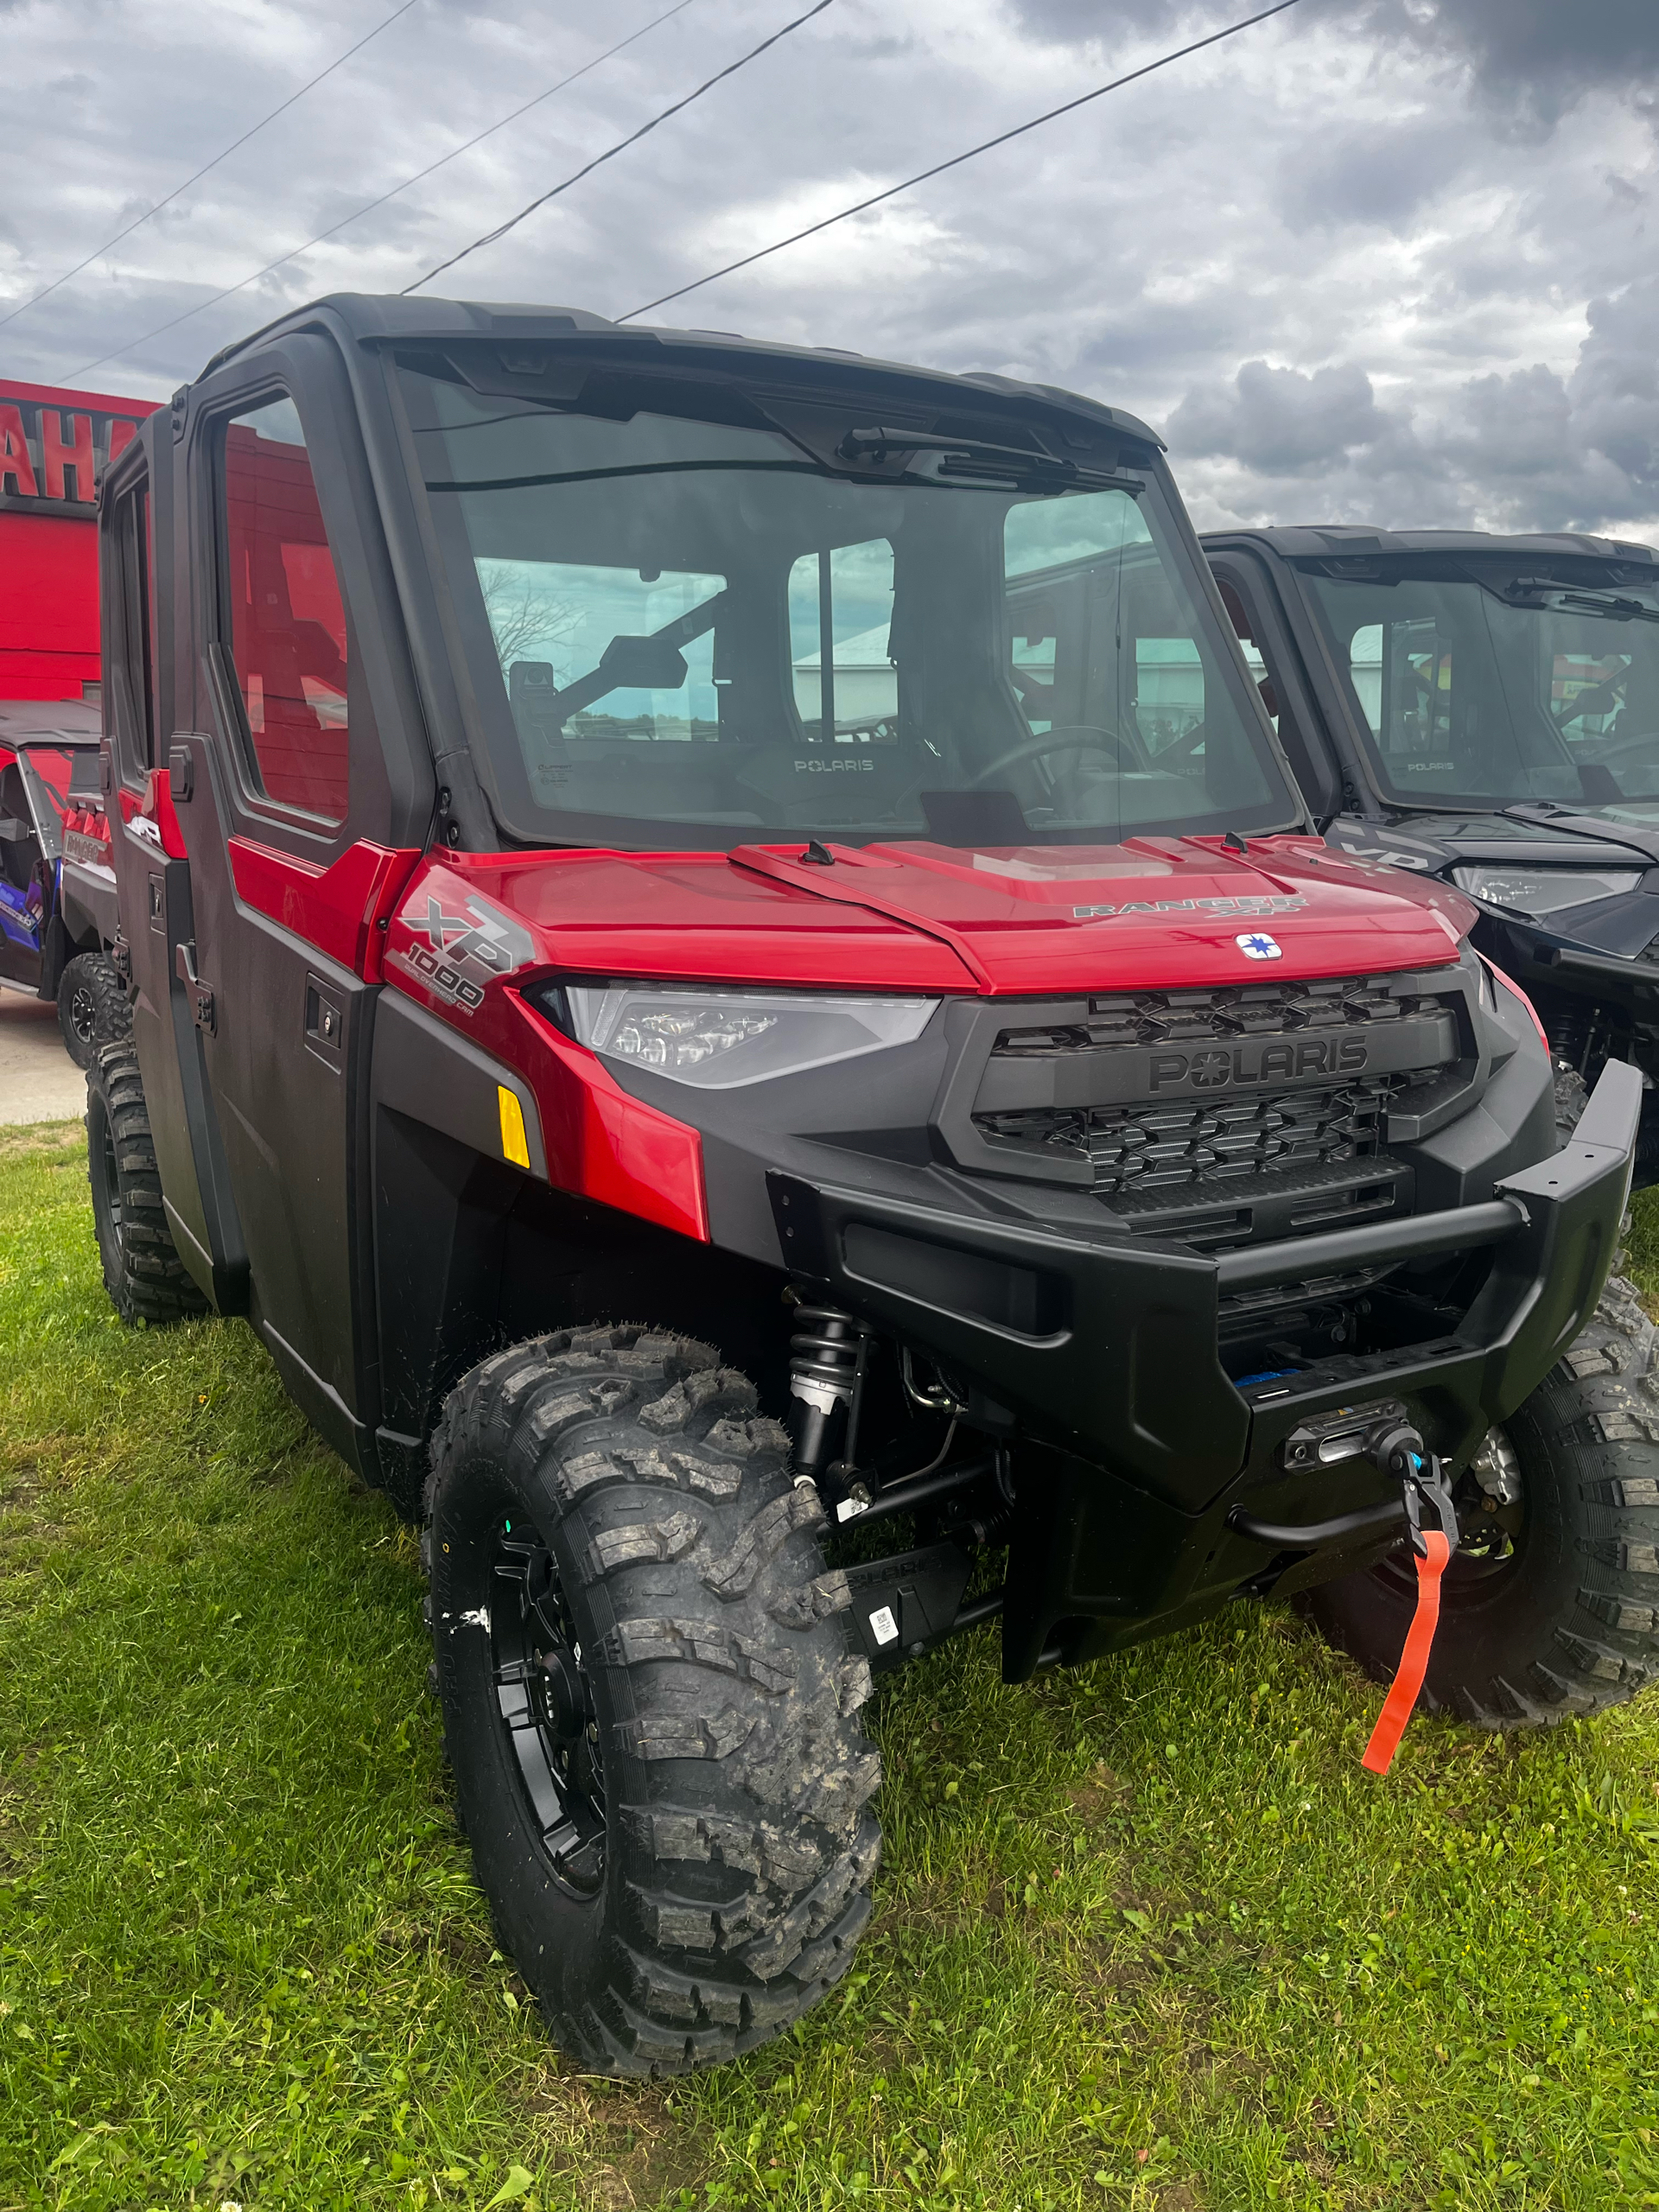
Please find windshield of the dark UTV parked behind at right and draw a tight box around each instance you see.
[1303,569,1659,807]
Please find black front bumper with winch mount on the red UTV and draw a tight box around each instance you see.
[767,1062,1643,1679]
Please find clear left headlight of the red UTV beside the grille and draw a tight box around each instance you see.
[562,984,938,1090]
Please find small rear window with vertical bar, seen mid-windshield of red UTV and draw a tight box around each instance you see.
[790,537,898,746]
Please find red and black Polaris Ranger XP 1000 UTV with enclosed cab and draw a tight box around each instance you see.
[88,296,1655,2073]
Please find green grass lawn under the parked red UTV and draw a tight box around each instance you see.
[0,1130,1659,2212]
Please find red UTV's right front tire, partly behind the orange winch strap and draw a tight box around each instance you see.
[1300,1276,1659,1730]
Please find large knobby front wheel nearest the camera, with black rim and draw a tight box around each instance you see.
[423,1327,880,2075]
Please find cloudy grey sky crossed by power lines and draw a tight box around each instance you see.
[0,0,1659,540]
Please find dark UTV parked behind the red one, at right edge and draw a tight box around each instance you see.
[1204,524,1659,1188]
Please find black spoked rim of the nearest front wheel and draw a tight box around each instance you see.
[489,1516,604,1897]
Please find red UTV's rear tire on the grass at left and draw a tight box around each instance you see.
[86,1042,208,1330]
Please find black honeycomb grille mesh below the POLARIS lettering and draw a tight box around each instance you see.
[976,1075,1400,1199]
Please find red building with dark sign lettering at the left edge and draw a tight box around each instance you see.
[0,380,155,702]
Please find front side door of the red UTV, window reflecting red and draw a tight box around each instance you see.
[168,358,416,1473]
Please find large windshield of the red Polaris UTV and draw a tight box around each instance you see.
[403,365,1296,847]
